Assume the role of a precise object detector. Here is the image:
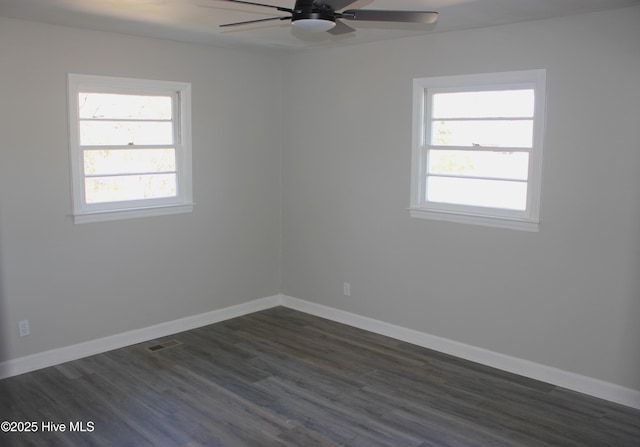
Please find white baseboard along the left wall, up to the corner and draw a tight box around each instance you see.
[0,295,281,379]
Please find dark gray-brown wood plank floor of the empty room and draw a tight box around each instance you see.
[0,307,640,447]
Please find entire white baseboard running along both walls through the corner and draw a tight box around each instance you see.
[0,295,640,409]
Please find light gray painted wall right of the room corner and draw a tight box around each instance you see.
[282,7,640,389]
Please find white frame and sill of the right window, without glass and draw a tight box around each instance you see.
[409,69,546,231]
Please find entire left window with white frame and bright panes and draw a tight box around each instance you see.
[68,74,193,223]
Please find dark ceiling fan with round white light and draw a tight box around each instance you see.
[220,0,438,35]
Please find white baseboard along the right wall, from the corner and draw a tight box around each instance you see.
[280,295,640,409]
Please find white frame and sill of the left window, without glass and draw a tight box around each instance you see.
[67,73,193,223]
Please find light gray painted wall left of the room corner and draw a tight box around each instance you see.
[0,19,282,360]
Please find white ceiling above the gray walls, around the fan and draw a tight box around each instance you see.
[0,0,640,49]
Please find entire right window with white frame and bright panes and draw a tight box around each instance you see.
[410,70,545,231]
